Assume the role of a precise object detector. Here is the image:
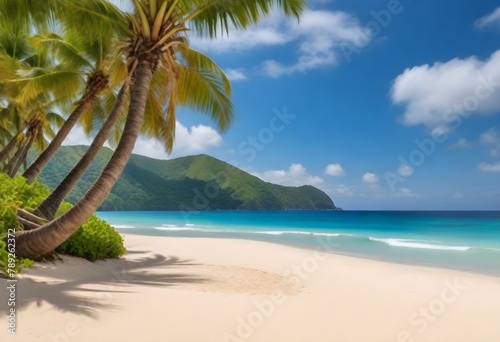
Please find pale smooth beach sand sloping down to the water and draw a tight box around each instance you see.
[0,235,500,342]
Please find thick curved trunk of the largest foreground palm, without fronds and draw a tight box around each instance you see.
[15,61,153,258]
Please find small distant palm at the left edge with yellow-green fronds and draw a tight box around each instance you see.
[0,23,71,175]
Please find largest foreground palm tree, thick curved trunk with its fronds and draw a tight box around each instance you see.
[16,0,305,257]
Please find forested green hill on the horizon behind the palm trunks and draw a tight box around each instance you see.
[40,146,337,210]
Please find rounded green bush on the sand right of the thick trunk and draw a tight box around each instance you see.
[56,215,125,261]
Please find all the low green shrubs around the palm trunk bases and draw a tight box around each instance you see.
[0,174,125,276]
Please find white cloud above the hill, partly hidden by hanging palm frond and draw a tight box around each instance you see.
[134,121,222,159]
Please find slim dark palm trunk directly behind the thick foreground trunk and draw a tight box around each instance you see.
[34,85,128,220]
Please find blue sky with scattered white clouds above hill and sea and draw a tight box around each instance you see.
[67,0,500,210]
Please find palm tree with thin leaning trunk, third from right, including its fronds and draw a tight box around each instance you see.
[0,0,129,181]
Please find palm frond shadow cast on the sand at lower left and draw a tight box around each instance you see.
[0,254,207,318]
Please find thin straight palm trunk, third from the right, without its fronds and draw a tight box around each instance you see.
[23,74,107,182]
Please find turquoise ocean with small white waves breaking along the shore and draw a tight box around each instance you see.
[97,211,500,276]
